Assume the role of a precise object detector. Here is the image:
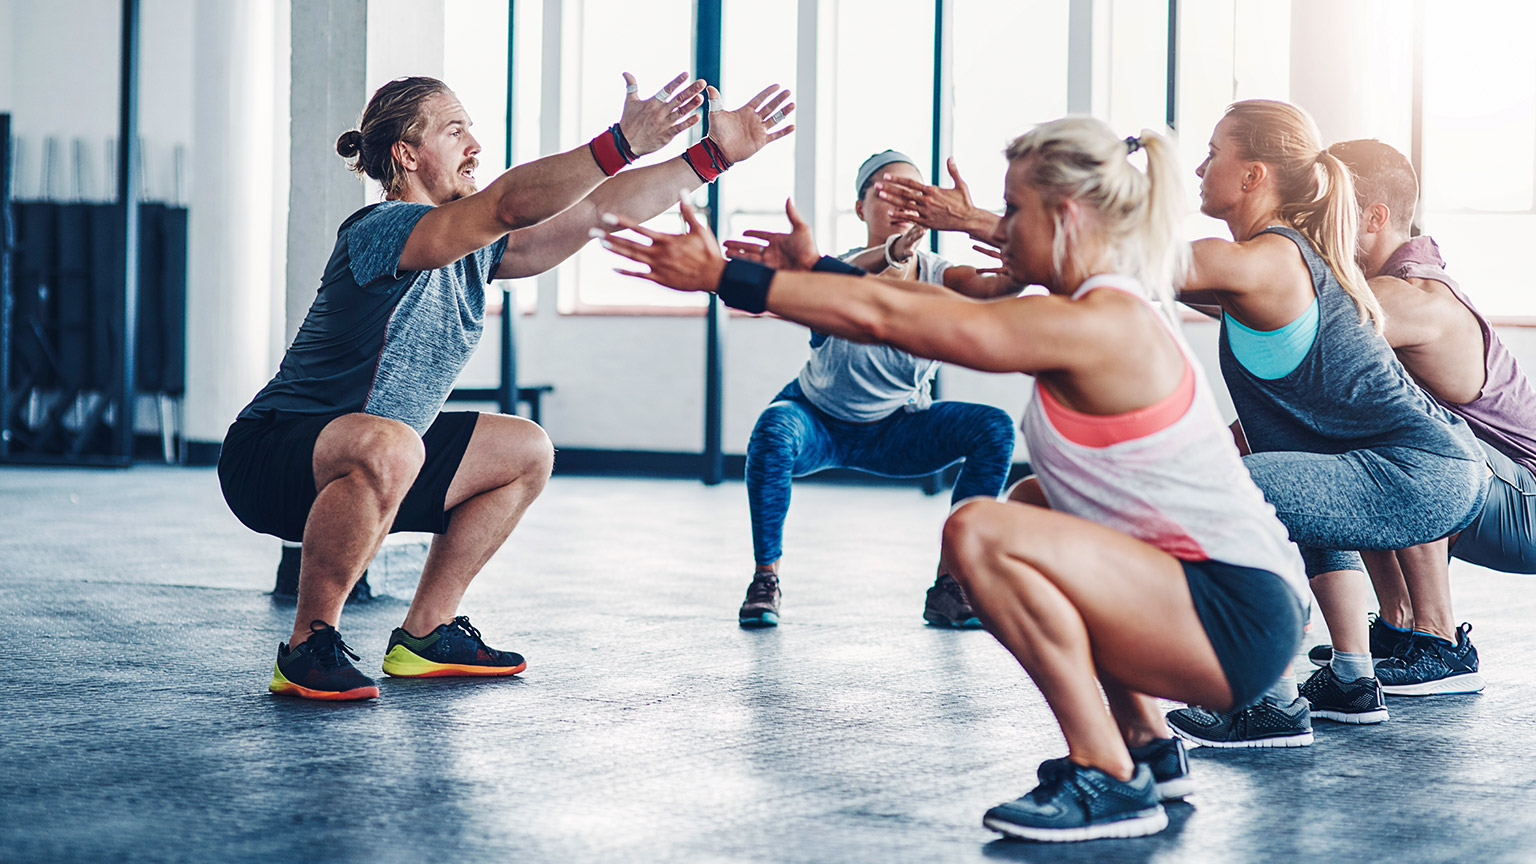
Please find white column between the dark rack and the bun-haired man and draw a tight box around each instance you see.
[184,0,281,463]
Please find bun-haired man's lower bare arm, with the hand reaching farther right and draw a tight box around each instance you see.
[495,85,794,278]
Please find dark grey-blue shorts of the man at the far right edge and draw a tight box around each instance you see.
[1450,441,1536,573]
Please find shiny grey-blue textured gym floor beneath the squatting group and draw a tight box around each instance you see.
[0,467,1536,861]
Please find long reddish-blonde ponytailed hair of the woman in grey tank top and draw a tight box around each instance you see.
[1226,98,1385,334]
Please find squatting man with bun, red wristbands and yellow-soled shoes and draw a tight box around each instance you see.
[218,74,794,700]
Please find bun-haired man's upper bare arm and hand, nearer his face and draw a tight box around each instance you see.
[399,74,703,271]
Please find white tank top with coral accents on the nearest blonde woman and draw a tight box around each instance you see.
[1020,275,1309,604]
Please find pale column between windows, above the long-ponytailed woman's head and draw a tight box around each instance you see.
[1290,0,1413,147]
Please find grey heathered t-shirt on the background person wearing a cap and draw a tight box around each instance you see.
[800,249,949,423]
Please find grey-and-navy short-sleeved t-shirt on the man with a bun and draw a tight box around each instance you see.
[240,201,507,435]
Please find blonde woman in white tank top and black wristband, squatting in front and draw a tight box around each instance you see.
[605,118,1306,841]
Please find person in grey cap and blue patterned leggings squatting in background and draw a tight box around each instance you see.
[727,151,1017,627]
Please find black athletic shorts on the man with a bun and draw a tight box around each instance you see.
[218,410,479,543]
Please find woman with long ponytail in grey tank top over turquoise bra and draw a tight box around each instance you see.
[1169,100,1487,747]
